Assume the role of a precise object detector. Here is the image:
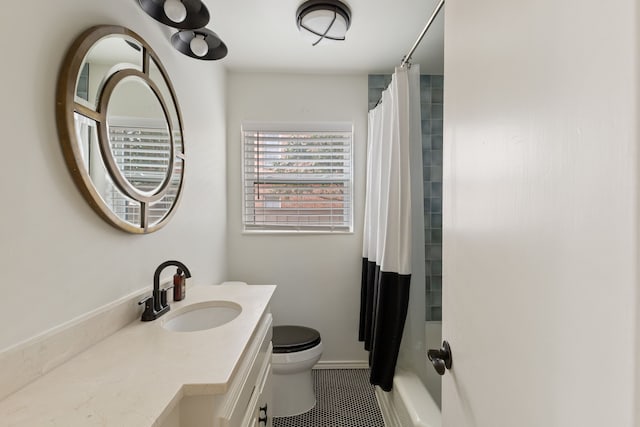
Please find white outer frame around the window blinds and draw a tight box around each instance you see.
[240,121,355,235]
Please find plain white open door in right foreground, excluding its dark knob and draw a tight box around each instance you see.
[443,0,640,427]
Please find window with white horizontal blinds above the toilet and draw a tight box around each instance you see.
[242,123,353,232]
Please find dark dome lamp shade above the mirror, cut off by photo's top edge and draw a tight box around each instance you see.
[138,0,209,30]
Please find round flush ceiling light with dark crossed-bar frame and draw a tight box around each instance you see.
[296,0,351,46]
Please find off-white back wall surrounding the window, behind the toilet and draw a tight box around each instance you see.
[227,73,367,361]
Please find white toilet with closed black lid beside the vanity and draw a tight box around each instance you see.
[271,325,322,417]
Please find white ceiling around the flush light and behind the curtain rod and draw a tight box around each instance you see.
[203,0,444,74]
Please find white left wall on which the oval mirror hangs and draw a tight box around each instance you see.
[0,0,226,350]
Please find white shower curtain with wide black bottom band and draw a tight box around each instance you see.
[359,66,424,391]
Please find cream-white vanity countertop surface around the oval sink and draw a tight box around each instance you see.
[0,285,275,427]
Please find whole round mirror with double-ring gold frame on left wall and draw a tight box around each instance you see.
[56,26,185,233]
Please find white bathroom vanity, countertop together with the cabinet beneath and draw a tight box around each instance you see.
[0,285,275,427]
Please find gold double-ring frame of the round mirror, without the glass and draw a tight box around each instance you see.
[56,25,185,234]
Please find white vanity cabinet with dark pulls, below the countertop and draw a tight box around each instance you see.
[174,312,273,427]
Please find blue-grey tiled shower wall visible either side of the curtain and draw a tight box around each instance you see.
[369,74,443,320]
